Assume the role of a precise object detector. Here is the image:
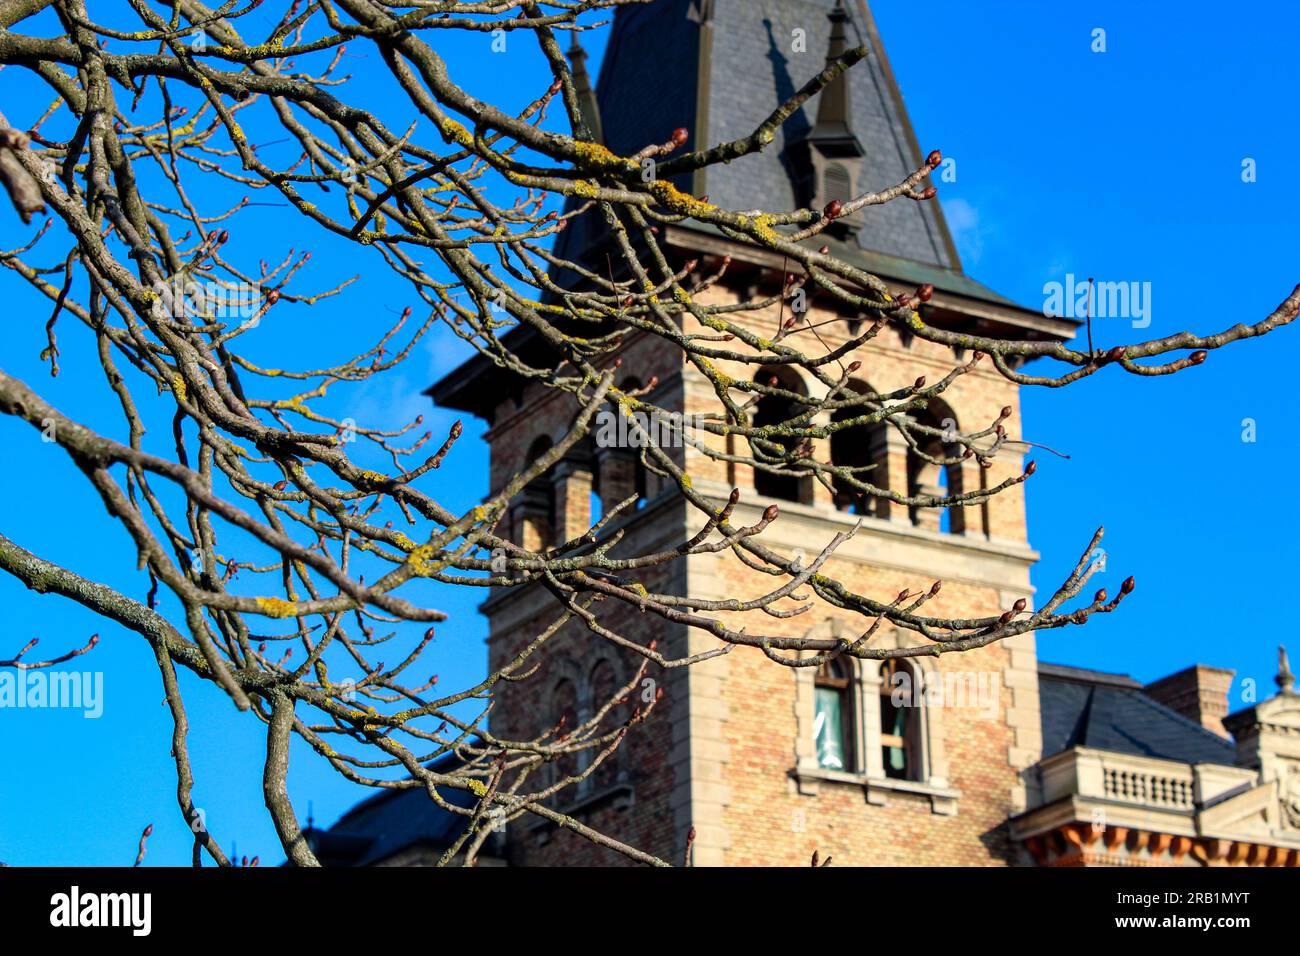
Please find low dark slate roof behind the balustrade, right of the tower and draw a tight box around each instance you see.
[1039,663,1236,766]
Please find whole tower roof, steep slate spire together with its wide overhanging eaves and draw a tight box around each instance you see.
[426,0,1078,416]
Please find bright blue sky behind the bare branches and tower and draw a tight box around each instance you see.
[0,0,1300,865]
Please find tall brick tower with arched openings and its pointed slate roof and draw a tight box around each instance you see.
[430,0,1075,865]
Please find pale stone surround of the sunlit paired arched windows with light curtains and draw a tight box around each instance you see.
[793,618,961,816]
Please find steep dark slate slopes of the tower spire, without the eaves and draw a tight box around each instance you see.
[579,0,962,267]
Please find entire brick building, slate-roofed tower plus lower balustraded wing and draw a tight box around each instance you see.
[314,0,1300,866]
